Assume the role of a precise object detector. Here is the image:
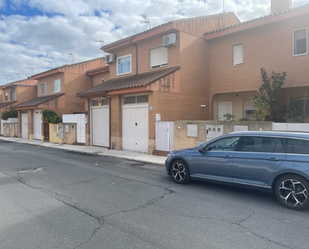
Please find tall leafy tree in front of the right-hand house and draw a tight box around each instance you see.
[253,68,288,121]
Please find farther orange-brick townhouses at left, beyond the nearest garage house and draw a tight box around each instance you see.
[0,58,105,140]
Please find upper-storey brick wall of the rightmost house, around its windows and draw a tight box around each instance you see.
[208,16,309,118]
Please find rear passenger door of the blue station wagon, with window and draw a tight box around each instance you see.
[232,136,286,186]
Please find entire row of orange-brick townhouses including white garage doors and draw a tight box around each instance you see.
[0,0,309,154]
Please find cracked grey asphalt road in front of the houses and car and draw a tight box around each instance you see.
[0,140,309,249]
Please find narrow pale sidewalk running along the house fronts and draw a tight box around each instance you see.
[0,136,166,165]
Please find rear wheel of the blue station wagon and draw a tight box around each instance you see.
[275,174,309,210]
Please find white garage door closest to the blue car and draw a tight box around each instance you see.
[122,104,149,153]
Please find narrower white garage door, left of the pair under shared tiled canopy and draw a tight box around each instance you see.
[91,106,109,147]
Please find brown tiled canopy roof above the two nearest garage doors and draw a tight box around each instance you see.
[76,67,180,97]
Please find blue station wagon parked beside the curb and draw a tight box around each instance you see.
[165,131,309,210]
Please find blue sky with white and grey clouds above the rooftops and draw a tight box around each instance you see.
[0,0,308,85]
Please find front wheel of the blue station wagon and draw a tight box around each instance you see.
[170,159,191,184]
